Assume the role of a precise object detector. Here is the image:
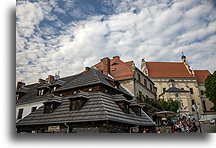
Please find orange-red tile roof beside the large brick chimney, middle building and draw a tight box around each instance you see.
[95,56,134,80]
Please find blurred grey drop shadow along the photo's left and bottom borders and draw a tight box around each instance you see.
[10,8,210,143]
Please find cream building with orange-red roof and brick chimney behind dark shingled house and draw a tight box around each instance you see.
[94,56,156,99]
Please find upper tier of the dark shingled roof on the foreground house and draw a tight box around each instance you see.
[16,69,132,105]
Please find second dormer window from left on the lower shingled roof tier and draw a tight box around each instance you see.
[68,92,89,111]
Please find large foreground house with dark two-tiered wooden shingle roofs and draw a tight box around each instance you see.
[16,68,155,133]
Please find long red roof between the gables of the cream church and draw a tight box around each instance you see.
[146,62,194,78]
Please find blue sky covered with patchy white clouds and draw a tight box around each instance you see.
[16,0,216,84]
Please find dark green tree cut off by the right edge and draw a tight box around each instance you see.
[205,71,216,111]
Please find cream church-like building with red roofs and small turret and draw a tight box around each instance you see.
[141,55,215,119]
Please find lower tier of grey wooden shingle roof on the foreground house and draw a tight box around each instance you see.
[17,92,154,126]
